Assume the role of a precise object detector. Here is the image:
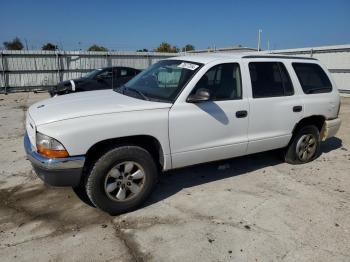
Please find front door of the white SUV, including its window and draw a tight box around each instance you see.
[169,63,249,168]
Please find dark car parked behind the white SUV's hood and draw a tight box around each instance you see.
[50,66,140,96]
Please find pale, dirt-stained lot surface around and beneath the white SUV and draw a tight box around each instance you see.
[0,93,350,262]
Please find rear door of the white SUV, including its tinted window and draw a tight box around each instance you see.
[246,59,304,153]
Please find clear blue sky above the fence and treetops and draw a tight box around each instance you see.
[0,0,350,50]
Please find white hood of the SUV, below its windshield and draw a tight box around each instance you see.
[29,90,171,125]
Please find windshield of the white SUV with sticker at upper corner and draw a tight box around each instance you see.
[117,60,202,102]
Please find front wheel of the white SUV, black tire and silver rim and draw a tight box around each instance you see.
[86,146,158,215]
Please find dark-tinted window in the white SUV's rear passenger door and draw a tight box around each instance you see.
[249,62,294,98]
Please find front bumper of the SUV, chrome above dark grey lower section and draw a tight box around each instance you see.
[24,133,85,187]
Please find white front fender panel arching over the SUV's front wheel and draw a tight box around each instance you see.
[37,108,170,164]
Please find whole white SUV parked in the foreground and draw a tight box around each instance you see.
[24,54,340,214]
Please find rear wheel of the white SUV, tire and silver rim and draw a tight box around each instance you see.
[284,125,320,165]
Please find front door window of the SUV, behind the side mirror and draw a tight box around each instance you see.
[191,63,242,100]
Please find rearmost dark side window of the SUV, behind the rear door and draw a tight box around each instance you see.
[292,63,332,94]
